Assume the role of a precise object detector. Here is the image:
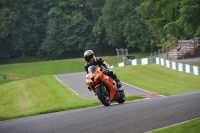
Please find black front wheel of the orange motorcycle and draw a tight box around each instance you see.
[95,87,110,106]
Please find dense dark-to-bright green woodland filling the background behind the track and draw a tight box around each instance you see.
[0,0,200,62]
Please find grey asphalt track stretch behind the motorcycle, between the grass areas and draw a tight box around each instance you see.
[56,72,153,99]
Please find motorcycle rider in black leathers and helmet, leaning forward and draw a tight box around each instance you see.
[84,50,122,90]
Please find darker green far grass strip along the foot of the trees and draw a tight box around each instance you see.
[0,53,149,85]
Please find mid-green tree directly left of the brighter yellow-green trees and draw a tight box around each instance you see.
[102,0,150,52]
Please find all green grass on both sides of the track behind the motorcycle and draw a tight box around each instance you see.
[0,54,200,132]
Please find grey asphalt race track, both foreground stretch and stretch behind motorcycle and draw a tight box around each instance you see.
[0,72,200,133]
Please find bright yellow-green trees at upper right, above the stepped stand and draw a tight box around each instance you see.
[136,0,200,44]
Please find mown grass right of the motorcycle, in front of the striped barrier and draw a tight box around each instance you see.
[113,64,200,95]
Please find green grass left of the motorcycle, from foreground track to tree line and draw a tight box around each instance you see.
[0,53,148,120]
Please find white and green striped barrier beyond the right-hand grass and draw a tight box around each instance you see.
[110,57,200,75]
